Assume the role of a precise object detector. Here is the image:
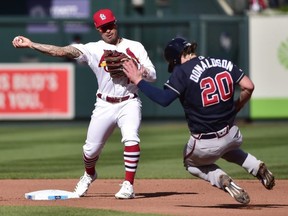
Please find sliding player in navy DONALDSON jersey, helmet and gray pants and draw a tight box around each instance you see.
[124,38,275,204]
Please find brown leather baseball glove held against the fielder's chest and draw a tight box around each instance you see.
[103,50,130,78]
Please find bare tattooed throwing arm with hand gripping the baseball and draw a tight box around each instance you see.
[12,36,82,58]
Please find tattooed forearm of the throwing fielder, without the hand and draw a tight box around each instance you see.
[31,43,81,58]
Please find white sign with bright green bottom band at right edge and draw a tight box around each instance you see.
[249,15,288,119]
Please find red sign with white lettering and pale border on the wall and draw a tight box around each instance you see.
[0,63,75,120]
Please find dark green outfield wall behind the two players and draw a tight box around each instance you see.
[0,14,250,119]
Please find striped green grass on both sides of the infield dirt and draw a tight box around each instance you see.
[0,121,288,216]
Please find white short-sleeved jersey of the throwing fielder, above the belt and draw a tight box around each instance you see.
[71,38,156,97]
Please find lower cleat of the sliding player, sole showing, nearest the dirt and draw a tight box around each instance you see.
[220,175,250,204]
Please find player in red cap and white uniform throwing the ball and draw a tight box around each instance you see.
[12,9,156,199]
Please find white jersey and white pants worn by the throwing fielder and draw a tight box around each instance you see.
[71,38,156,158]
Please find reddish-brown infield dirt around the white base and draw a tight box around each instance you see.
[0,179,288,216]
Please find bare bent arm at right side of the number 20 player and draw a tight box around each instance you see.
[235,75,254,112]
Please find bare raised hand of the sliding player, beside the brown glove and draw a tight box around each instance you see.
[123,60,145,85]
